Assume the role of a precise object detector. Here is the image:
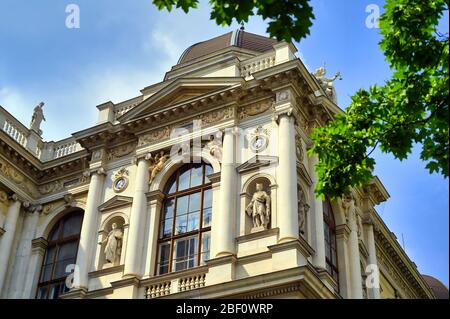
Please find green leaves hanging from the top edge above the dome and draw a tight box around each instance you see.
[153,0,314,42]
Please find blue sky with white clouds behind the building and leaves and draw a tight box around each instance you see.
[0,0,449,286]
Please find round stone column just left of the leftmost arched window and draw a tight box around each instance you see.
[11,205,42,299]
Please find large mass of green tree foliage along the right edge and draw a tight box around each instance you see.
[310,0,449,197]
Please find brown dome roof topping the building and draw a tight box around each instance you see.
[178,30,278,64]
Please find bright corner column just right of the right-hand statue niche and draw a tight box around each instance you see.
[277,113,299,243]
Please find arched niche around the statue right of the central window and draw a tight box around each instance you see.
[240,174,277,236]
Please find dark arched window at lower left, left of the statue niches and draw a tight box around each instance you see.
[36,210,83,299]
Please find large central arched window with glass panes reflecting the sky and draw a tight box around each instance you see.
[156,163,213,275]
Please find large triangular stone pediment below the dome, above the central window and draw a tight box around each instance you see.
[118,77,242,123]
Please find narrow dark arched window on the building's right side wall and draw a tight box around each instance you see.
[323,199,339,283]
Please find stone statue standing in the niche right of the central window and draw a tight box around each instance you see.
[246,183,270,233]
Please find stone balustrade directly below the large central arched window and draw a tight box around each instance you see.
[142,268,206,299]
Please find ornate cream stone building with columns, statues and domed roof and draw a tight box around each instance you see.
[0,30,434,299]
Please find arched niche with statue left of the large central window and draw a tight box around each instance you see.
[97,213,128,270]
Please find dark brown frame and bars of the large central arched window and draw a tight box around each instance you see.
[154,161,212,276]
